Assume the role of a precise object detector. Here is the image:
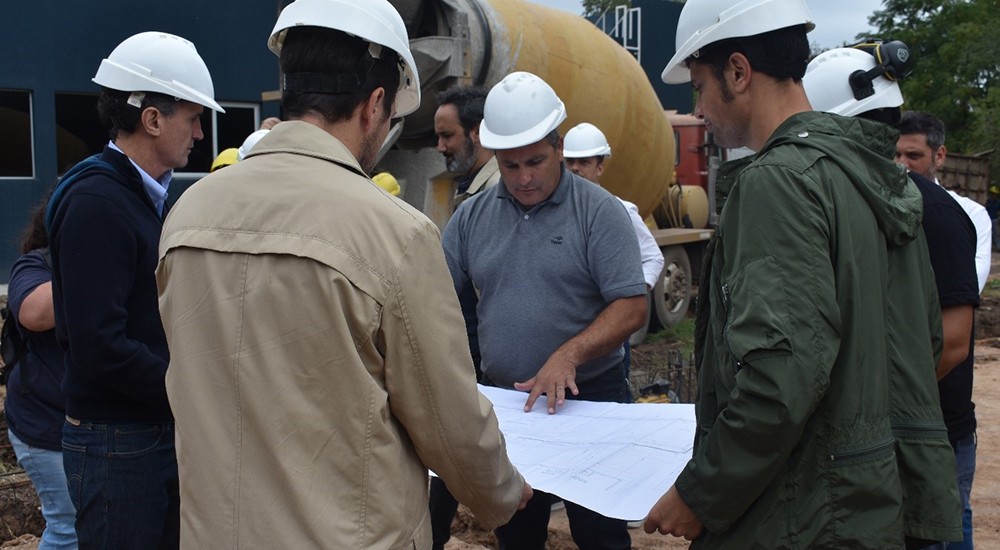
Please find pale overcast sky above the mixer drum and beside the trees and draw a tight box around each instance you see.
[529,0,882,49]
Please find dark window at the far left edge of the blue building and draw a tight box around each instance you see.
[0,90,35,178]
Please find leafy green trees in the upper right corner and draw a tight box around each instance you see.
[868,0,1000,188]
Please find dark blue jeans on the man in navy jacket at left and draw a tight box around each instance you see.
[63,419,180,550]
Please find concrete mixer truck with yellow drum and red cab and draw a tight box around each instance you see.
[380,0,715,332]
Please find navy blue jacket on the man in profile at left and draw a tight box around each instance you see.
[49,147,173,422]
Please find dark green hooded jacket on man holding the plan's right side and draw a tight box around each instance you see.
[676,112,961,550]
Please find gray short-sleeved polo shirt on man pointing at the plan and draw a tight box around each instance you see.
[442,168,646,388]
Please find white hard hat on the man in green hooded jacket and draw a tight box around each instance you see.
[661,0,816,84]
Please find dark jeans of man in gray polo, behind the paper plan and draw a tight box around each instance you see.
[495,368,632,550]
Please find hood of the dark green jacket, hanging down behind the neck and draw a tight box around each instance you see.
[758,111,924,246]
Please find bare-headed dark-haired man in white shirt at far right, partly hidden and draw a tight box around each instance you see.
[896,111,993,292]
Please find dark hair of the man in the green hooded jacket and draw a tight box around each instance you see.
[684,25,810,86]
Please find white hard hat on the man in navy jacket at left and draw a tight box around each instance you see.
[93,31,226,113]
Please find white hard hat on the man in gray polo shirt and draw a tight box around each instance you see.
[479,71,566,150]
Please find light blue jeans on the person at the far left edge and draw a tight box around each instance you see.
[7,430,77,550]
